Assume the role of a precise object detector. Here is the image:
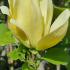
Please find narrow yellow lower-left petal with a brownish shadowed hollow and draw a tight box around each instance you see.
[8,23,30,47]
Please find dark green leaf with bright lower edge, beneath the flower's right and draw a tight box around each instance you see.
[43,44,69,65]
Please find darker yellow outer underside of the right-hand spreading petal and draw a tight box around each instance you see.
[36,22,68,50]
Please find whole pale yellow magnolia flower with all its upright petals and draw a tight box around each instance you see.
[0,0,70,50]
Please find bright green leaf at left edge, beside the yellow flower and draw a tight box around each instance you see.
[0,23,15,46]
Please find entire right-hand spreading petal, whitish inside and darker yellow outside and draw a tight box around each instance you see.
[36,10,70,50]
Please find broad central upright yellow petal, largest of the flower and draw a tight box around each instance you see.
[13,0,43,46]
